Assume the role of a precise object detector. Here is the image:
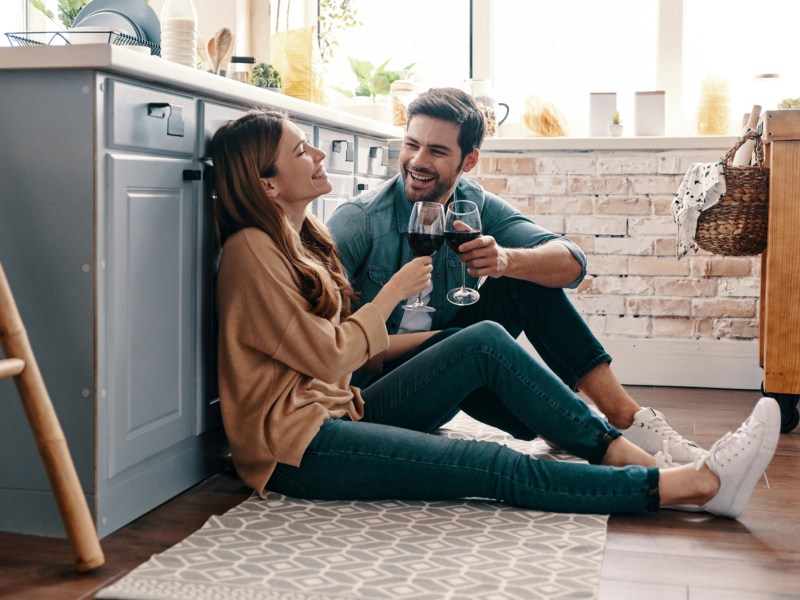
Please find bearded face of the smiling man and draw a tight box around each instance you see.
[399,115,478,204]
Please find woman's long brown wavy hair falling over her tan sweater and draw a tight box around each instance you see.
[211,110,354,319]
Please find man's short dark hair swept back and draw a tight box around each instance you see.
[408,87,486,160]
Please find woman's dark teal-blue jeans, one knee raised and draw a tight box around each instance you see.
[267,321,658,514]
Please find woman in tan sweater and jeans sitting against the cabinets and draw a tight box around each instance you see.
[212,111,780,518]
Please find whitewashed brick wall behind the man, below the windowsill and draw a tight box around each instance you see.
[470,149,761,341]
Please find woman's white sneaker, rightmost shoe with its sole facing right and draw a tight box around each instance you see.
[695,397,781,519]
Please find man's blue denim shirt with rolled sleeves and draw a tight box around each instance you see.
[326,175,586,334]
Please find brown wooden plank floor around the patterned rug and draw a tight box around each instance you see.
[0,387,800,600]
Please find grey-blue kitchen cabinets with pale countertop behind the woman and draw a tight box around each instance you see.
[0,45,400,537]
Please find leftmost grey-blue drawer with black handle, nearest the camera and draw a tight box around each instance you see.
[106,80,197,154]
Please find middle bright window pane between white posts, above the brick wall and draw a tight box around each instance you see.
[491,0,658,137]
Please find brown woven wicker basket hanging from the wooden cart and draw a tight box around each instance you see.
[695,131,769,256]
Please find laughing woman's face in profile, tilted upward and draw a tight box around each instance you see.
[266,120,333,214]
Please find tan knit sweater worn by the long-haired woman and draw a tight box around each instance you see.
[217,228,389,496]
